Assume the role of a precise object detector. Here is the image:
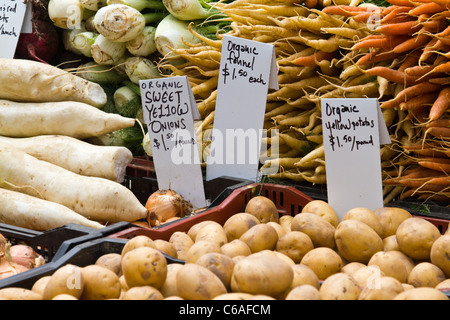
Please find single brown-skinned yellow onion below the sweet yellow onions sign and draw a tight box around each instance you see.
[145,189,192,226]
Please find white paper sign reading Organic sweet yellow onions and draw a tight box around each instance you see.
[139,76,206,208]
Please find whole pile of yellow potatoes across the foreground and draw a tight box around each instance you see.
[0,196,450,300]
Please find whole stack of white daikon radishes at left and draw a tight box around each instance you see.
[0,59,147,230]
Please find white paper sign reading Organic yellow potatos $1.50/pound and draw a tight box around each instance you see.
[321,98,390,220]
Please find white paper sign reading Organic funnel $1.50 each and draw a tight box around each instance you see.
[206,36,278,181]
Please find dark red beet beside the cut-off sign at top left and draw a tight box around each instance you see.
[15,0,60,63]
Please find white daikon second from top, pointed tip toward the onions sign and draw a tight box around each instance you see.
[0,99,135,139]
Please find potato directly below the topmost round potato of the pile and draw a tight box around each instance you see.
[239,223,278,253]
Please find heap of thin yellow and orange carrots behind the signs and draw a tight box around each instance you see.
[158,0,450,203]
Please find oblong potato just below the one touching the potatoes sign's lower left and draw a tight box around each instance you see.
[291,212,336,249]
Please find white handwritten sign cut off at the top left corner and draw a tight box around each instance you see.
[0,0,27,59]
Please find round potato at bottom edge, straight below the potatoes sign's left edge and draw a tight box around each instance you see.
[319,272,361,300]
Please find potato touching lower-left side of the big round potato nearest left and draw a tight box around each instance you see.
[80,264,121,300]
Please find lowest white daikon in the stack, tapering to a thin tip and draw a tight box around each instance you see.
[0,188,103,231]
